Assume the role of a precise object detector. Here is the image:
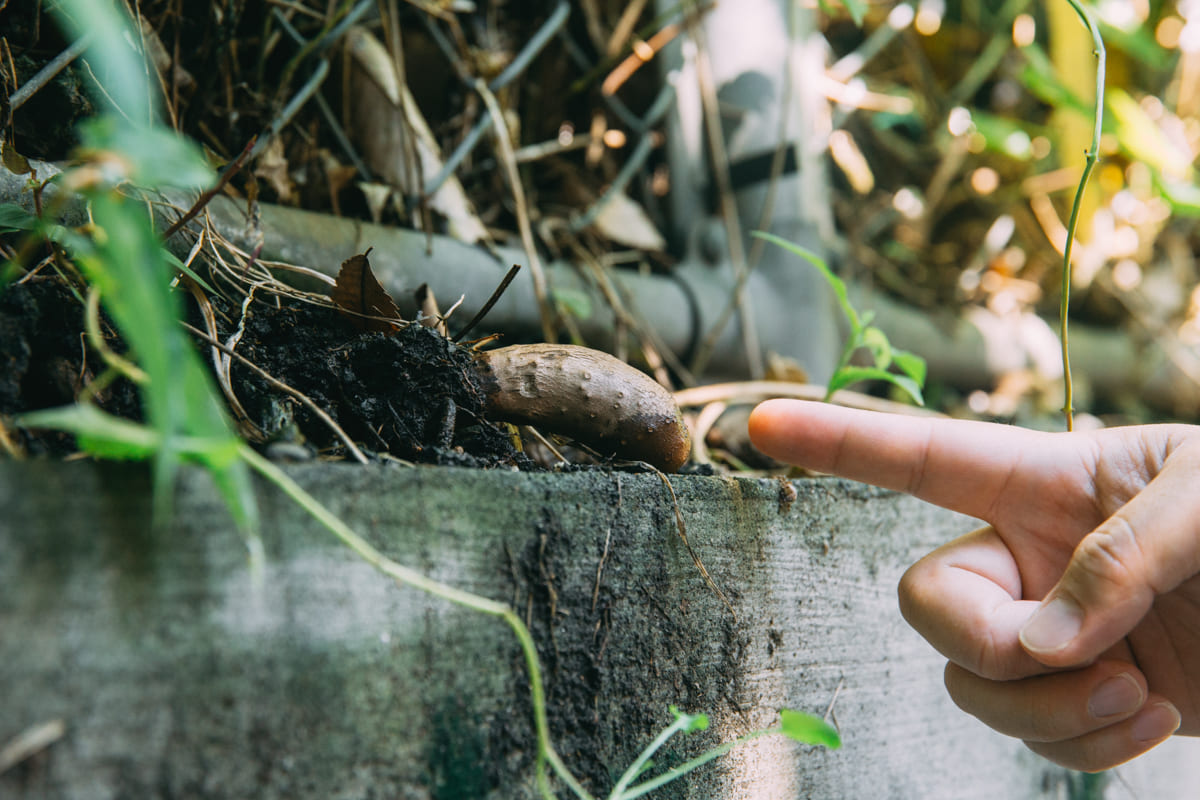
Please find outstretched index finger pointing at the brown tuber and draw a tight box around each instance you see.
[750,399,1051,517]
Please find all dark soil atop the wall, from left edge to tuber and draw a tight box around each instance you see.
[0,278,535,469]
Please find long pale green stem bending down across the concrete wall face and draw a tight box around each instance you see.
[239,444,595,800]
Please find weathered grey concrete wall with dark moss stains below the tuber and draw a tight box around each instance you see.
[0,463,1200,800]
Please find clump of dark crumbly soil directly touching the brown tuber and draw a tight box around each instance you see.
[219,296,533,468]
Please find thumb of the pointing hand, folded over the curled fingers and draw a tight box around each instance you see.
[1020,452,1200,667]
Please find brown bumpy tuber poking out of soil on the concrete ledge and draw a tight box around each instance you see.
[475,344,691,473]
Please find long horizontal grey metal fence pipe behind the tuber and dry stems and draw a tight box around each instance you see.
[0,162,1200,416]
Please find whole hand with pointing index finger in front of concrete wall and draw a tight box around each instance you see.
[750,399,1200,771]
